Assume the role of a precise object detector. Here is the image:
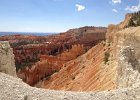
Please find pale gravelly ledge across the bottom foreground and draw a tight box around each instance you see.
[0,73,140,100]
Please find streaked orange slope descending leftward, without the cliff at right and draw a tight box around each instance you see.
[42,43,116,91]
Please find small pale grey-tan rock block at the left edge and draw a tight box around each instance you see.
[0,41,16,76]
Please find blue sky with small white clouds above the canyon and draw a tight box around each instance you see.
[0,0,140,32]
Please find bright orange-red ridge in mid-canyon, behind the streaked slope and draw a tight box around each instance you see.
[17,45,84,85]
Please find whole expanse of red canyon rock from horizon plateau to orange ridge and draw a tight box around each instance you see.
[0,27,106,85]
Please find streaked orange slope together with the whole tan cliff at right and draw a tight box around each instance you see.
[40,15,140,91]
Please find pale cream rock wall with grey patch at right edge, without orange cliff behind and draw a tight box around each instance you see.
[115,27,140,88]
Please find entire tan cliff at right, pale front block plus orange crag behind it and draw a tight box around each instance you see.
[107,14,140,88]
